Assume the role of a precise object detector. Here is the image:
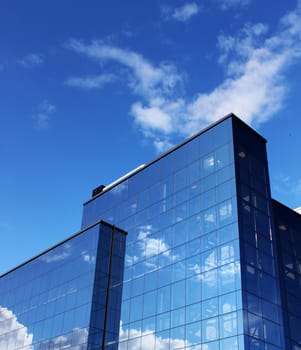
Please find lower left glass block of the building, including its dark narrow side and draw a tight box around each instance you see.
[0,222,125,350]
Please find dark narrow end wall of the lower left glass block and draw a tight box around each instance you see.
[88,222,126,350]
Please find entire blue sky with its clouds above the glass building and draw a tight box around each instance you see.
[0,0,301,273]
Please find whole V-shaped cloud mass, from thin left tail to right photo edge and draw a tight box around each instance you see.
[67,1,301,151]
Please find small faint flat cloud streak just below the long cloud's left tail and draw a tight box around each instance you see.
[65,74,116,90]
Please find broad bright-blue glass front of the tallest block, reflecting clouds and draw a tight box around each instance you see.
[83,118,244,350]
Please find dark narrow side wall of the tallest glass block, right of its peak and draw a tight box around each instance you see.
[233,118,285,350]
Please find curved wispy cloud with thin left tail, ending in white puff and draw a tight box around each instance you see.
[67,40,183,148]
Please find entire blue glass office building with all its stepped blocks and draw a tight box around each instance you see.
[0,114,301,350]
